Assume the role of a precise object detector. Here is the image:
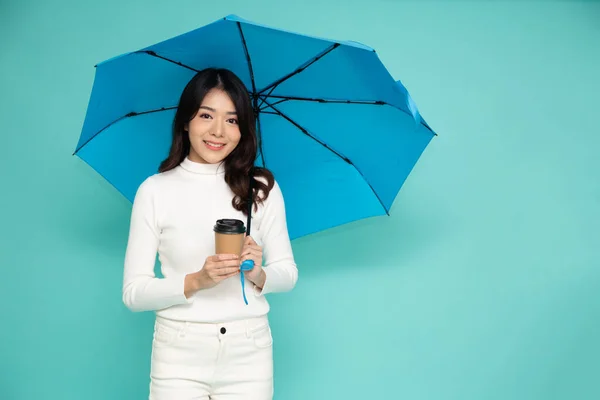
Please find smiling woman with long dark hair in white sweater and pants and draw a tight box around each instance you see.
[123,68,298,400]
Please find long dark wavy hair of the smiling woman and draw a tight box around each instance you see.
[159,68,275,215]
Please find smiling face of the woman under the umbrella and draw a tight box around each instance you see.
[187,89,241,164]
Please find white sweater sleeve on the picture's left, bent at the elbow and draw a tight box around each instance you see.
[123,177,193,311]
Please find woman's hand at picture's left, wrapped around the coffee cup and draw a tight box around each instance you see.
[184,254,240,297]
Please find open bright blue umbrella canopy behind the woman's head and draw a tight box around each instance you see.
[75,16,436,239]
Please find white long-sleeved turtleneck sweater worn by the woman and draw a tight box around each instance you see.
[123,158,298,322]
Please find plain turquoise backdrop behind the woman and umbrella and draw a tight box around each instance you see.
[0,0,600,400]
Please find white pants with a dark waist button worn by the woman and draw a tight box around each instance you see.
[150,316,273,400]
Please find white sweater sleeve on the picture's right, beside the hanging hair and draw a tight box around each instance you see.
[254,182,298,296]
